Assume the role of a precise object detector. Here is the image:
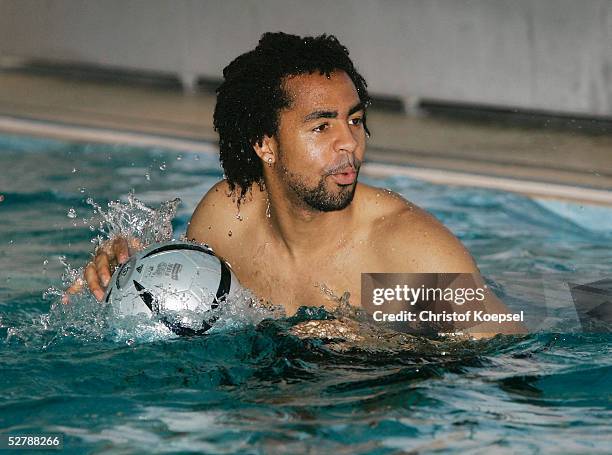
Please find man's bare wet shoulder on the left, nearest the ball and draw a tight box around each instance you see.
[187,180,262,256]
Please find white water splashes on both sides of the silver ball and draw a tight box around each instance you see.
[6,194,285,349]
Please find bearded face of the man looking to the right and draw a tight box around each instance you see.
[276,71,365,212]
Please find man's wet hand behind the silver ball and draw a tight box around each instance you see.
[62,237,142,303]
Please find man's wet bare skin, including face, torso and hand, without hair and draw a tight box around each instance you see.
[76,72,524,336]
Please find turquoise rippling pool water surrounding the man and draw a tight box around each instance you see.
[0,136,612,454]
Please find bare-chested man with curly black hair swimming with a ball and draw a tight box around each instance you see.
[71,33,524,336]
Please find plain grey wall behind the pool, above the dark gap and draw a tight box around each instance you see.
[0,0,612,117]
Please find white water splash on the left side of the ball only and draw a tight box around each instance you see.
[6,194,180,349]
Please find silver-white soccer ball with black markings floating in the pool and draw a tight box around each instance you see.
[104,241,242,335]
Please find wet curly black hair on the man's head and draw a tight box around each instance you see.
[213,32,370,201]
